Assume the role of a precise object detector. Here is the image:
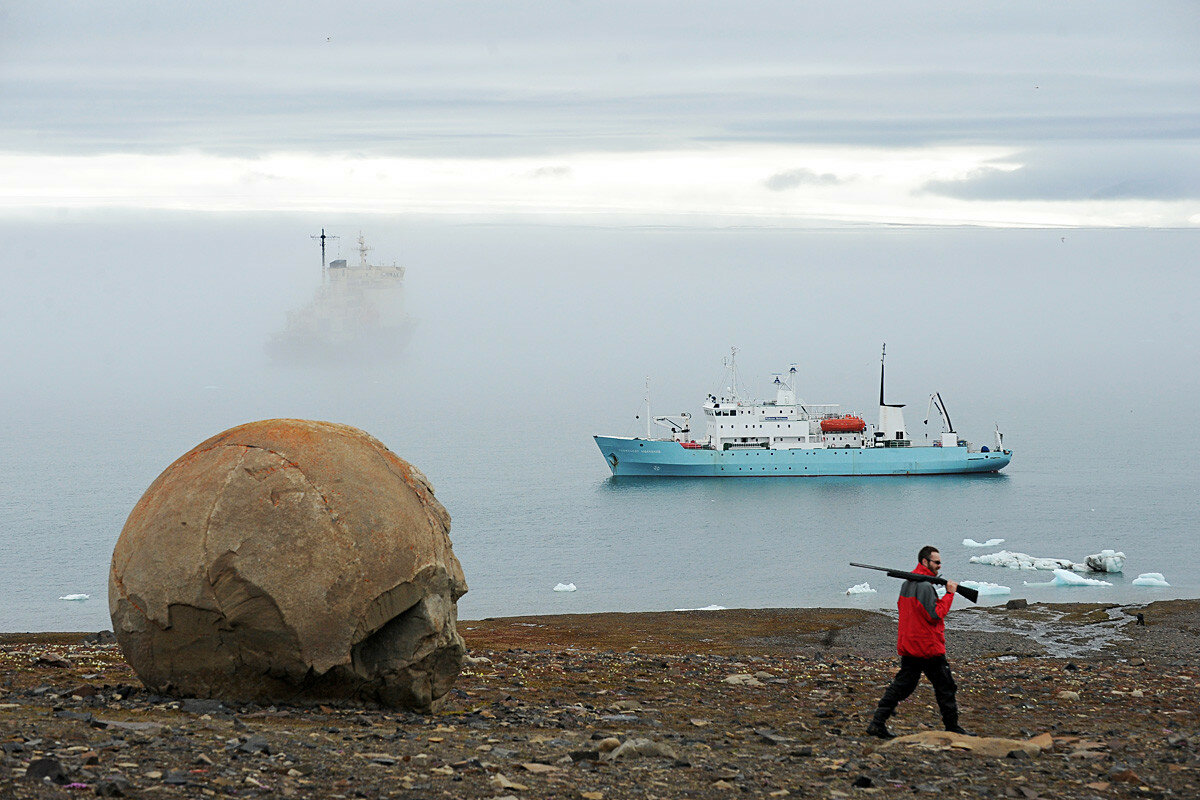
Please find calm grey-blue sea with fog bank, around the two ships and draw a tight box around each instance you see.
[0,211,1200,632]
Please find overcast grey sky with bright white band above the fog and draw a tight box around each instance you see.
[0,0,1200,227]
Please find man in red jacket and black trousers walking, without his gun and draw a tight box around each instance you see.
[866,545,966,739]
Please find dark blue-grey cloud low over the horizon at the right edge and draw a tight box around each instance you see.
[918,142,1200,200]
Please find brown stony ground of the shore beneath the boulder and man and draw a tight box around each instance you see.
[0,601,1200,800]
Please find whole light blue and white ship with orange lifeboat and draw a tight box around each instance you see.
[595,345,1013,477]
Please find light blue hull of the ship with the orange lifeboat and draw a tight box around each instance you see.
[594,437,1013,477]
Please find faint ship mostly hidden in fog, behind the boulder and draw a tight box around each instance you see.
[268,230,413,365]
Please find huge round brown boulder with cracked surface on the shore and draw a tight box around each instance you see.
[108,420,467,710]
